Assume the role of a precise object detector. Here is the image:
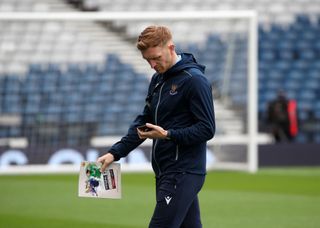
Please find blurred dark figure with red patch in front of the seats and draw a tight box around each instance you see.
[267,91,298,142]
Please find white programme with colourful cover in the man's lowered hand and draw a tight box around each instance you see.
[79,161,121,199]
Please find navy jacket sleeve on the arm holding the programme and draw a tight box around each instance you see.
[108,77,154,161]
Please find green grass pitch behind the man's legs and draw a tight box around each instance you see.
[0,167,320,228]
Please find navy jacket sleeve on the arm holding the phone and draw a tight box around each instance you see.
[168,72,215,145]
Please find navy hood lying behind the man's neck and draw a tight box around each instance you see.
[163,53,205,78]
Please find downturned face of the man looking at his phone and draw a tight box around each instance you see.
[141,44,174,74]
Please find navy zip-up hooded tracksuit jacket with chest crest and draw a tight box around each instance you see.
[109,53,215,176]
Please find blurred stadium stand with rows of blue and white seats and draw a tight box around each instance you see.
[0,0,320,146]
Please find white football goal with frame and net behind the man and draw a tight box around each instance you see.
[0,11,258,172]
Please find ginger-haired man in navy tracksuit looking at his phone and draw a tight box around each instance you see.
[98,26,215,228]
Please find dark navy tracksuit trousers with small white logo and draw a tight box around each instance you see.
[149,173,205,228]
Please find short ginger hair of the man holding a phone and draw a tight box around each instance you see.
[137,25,172,51]
